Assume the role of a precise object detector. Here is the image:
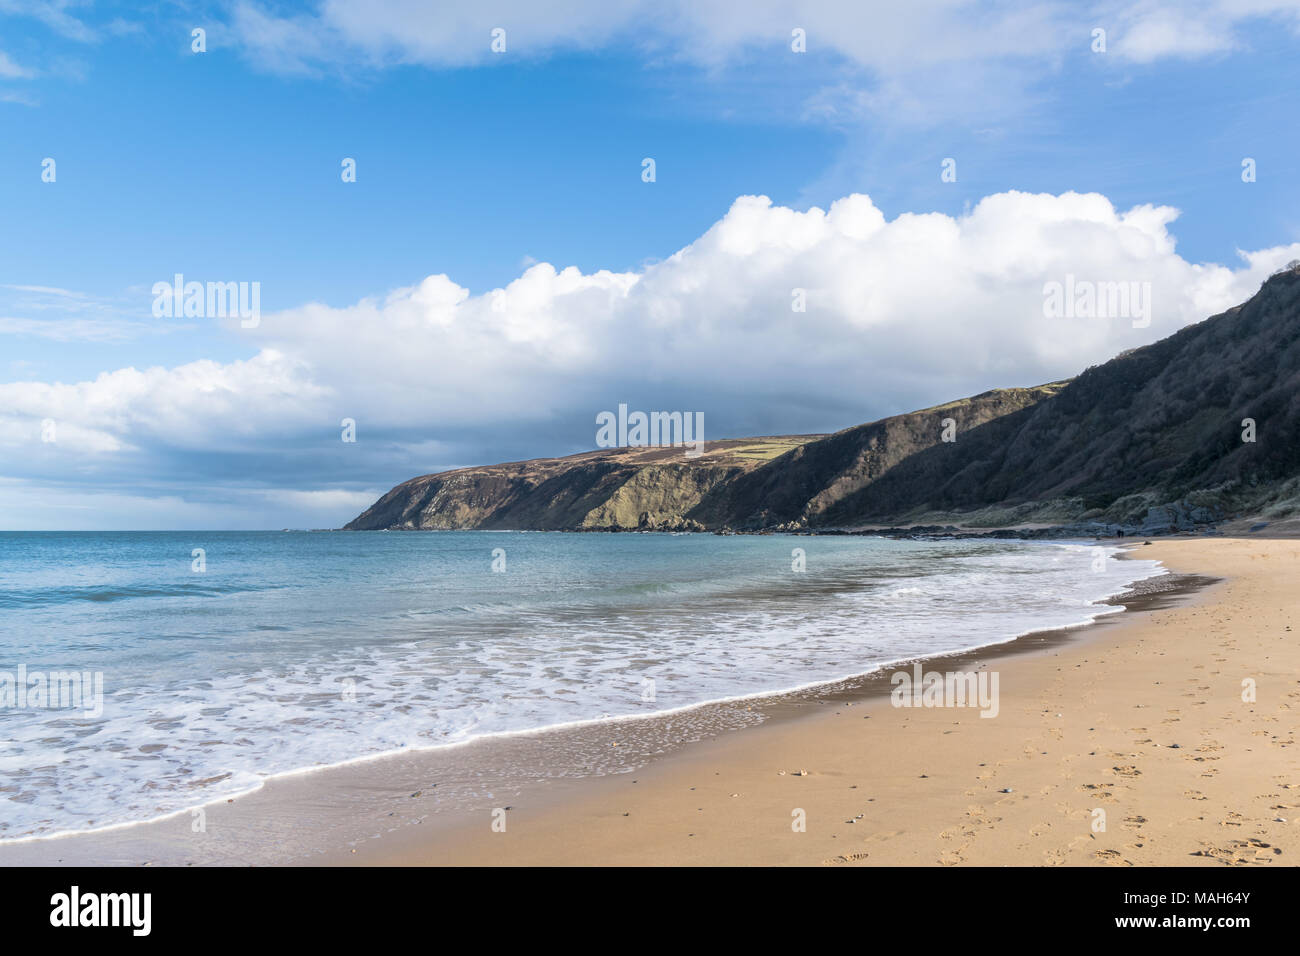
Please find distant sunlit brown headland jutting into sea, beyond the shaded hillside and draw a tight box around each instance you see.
[347,385,1060,531]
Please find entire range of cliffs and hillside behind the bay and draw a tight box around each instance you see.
[347,267,1300,531]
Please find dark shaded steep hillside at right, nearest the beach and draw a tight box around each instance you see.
[822,268,1300,525]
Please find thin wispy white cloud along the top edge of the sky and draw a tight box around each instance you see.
[213,0,1300,129]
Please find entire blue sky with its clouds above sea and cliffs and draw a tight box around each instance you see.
[0,0,1300,528]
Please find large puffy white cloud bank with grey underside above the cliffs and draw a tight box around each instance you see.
[0,193,1300,535]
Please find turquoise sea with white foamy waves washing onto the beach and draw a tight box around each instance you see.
[0,532,1160,839]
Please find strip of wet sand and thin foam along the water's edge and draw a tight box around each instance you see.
[0,538,1206,865]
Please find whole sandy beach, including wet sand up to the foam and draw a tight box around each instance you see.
[0,536,1300,866]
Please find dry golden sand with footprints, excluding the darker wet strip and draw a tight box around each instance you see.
[335,538,1300,866]
